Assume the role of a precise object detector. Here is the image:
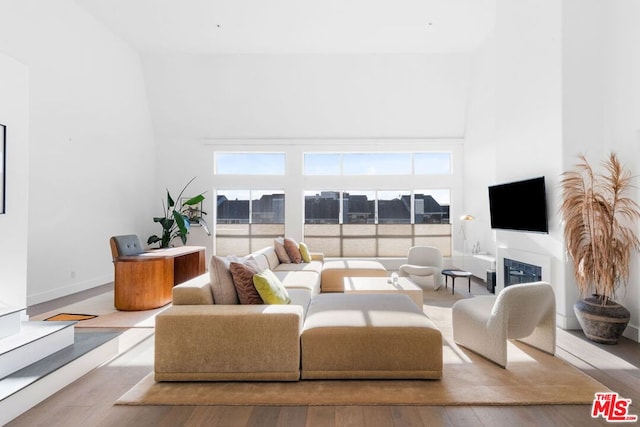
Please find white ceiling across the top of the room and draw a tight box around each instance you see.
[75,0,495,54]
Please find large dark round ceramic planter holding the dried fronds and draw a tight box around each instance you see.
[573,297,631,344]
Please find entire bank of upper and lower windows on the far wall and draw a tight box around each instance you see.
[213,145,461,257]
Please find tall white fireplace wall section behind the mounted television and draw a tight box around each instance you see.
[496,0,575,327]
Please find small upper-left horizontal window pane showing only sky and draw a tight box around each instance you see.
[215,152,285,175]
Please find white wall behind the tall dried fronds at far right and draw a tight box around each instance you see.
[562,0,640,341]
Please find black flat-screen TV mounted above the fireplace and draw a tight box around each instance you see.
[489,177,549,233]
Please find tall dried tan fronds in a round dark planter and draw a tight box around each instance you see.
[560,153,640,344]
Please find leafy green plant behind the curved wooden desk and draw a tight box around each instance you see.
[147,177,209,248]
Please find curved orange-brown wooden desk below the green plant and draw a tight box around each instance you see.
[114,246,205,311]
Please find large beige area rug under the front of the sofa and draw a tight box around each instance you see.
[116,332,609,406]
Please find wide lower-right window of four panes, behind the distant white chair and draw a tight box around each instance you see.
[304,189,451,257]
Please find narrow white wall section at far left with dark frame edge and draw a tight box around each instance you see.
[0,52,29,308]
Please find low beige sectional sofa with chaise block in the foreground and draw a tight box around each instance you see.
[154,247,442,381]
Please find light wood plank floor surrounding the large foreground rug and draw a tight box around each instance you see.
[8,283,640,427]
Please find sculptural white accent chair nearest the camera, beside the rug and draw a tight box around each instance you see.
[452,282,556,368]
